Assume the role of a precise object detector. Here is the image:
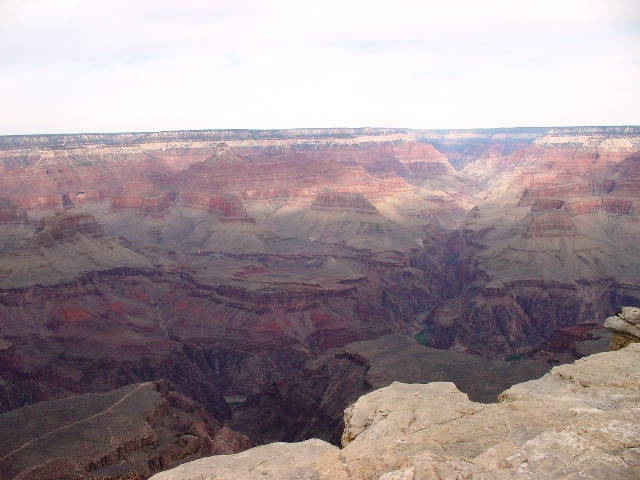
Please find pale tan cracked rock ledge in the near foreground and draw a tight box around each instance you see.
[152,344,640,480]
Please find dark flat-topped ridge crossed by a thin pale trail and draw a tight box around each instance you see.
[0,381,251,480]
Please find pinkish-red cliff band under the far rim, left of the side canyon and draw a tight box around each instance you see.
[0,132,464,218]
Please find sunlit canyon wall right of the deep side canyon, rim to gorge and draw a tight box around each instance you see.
[425,127,640,357]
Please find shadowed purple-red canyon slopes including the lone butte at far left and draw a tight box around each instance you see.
[0,217,450,418]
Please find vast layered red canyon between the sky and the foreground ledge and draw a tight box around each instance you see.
[0,127,640,480]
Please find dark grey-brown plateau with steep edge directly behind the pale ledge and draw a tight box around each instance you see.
[230,335,556,445]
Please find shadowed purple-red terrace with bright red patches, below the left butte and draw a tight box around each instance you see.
[0,256,424,418]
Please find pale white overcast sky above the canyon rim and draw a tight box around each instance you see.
[0,0,640,134]
